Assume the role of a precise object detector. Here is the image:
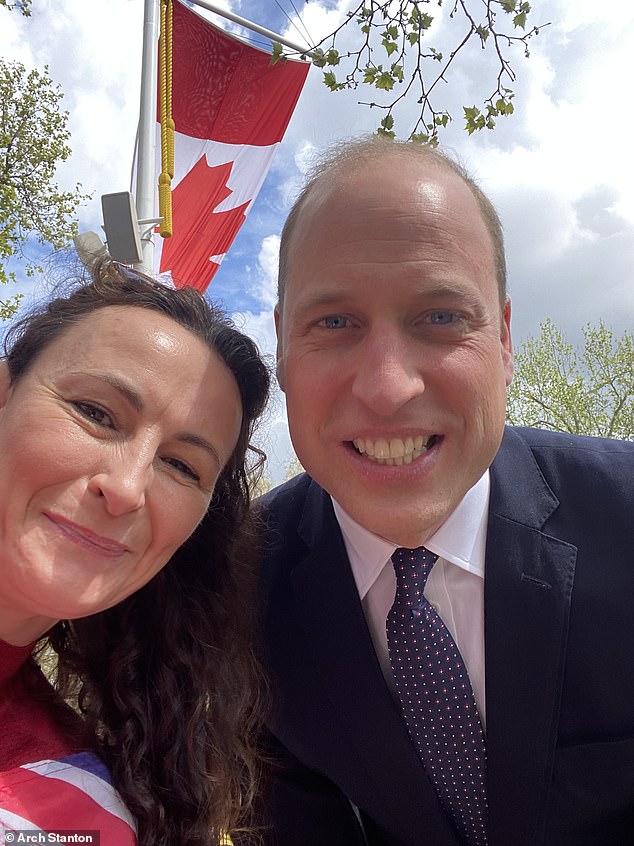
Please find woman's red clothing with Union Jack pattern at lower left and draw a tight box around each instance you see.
[0,640,137,846]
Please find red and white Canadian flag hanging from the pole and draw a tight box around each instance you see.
[154,1,310,291]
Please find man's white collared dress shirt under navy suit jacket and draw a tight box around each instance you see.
[333,470,490,726]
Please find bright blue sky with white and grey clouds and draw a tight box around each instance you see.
[0,0,634,481]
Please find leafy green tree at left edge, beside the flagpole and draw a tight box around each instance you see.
[0,59,89,319]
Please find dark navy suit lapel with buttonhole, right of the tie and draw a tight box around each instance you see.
[485,431,576,846]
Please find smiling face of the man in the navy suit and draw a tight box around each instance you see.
[276,156,513,547]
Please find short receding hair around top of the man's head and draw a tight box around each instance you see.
[277,135,507,311]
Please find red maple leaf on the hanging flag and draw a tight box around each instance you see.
[159,156,250,292]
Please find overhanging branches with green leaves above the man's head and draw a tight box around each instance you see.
[273,0,547,144]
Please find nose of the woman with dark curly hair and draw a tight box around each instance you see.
[88,448,154,516]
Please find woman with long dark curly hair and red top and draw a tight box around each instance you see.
[0,263,269,846]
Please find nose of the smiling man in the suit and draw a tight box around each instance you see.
[352,331,425,417]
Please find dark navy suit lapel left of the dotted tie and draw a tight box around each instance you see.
[292,483,456,846]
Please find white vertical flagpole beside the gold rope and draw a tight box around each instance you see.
[135,0,160,273]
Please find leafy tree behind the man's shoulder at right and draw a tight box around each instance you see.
[507,320,634,440]
